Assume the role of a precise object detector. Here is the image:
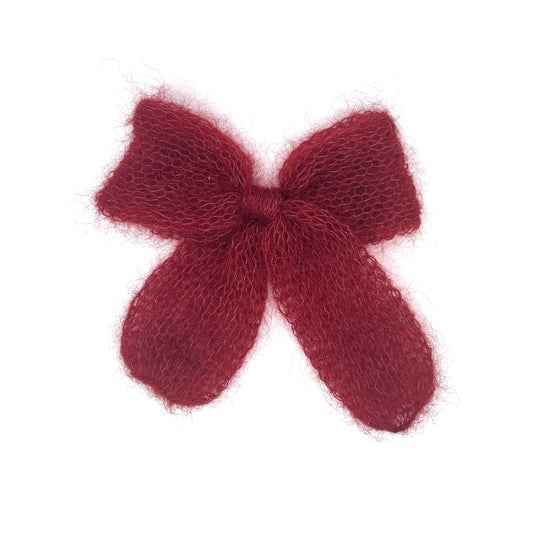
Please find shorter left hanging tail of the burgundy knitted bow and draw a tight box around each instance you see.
[121,232,267,407]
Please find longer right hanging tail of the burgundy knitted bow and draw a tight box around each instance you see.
[267,212,436,432]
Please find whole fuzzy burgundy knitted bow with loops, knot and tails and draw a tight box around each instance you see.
[96,98,436,432]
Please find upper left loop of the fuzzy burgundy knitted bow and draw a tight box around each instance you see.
[96,98,253,241]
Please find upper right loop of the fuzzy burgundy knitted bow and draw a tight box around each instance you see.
[279,110,420,244]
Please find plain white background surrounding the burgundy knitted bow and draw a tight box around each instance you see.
[0,0,533,533]
